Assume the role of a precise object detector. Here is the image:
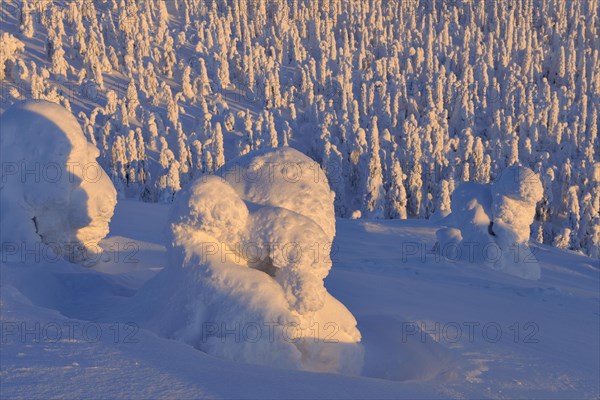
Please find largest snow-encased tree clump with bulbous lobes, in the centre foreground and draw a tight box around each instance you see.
[140,148,363,374]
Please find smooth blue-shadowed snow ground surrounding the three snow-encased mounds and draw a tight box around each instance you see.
[0,200,600,399]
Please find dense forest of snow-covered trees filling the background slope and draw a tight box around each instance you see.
[0,0,600,258]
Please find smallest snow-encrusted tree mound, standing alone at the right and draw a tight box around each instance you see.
[436,166,543,279]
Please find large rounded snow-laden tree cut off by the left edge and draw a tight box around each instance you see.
[0,101,116,265]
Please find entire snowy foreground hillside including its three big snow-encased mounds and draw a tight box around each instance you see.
[0,101,600,398]
